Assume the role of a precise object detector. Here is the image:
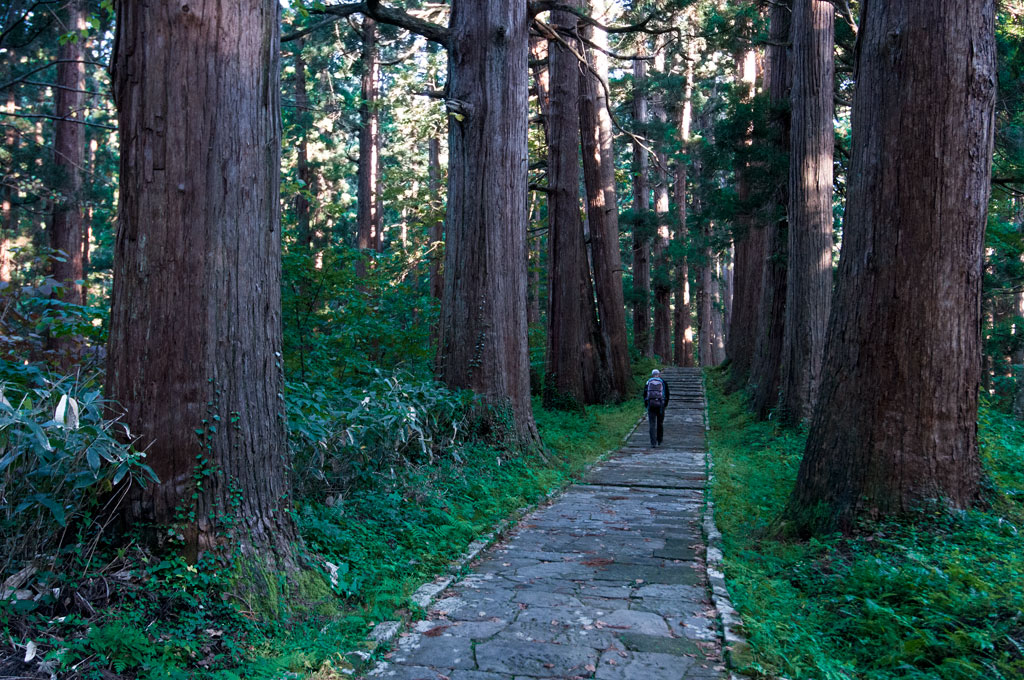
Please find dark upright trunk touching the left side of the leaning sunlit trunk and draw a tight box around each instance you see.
[544,5,607,406]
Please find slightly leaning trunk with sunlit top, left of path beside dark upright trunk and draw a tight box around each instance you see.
[580,0,633,399]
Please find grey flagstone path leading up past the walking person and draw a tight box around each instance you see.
[370,369,727,680]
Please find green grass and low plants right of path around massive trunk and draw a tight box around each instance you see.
[708,372,1024,680]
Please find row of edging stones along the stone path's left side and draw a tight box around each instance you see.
[360,413,646,659]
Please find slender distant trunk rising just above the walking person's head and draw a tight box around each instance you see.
[651,45,672,362]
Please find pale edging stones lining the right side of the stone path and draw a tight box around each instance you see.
[700,371,752,678]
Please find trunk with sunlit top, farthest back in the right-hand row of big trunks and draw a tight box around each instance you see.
[725,50,765,392]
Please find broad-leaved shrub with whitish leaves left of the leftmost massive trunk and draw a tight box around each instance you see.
[0,365,155,576]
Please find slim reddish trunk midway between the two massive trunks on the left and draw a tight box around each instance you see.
[355,16,382,266]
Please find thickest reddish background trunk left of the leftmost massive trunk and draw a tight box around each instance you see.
[50,0,85,307]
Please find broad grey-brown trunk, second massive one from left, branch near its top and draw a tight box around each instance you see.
[439,0,538,441]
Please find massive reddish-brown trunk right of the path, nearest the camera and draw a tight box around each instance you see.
[788,0,996,530]
